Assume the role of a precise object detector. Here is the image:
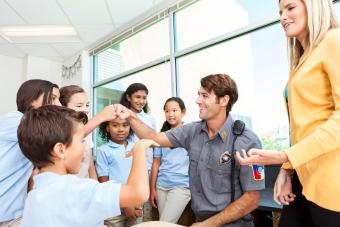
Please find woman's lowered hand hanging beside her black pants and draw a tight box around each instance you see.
[273,169,296,205]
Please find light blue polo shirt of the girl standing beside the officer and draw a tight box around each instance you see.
[153,147,189,188]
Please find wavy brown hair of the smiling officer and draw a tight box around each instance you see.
[201,74,238,115]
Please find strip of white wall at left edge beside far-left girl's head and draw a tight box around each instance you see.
[0,55,24,115]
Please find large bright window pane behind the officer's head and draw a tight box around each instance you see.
[178,24,289,149]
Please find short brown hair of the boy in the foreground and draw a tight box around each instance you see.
[18,105,87,168]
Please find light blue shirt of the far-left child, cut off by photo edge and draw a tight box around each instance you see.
[0,111,33,222]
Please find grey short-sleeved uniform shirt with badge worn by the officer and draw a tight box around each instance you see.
[165,115,265,215]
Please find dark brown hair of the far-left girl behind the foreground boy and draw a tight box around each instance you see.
[17,79,59,113]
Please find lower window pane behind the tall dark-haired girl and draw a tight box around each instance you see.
[95,63,172,138]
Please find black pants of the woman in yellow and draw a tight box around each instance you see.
[279,173,340,227]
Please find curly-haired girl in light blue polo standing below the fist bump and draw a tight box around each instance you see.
[96,118,143,227]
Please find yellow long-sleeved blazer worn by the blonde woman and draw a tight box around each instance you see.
[282,28,340,212]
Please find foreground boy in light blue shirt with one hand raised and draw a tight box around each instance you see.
[18,106,155,227]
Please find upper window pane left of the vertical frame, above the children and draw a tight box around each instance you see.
[95,18,170,81]
